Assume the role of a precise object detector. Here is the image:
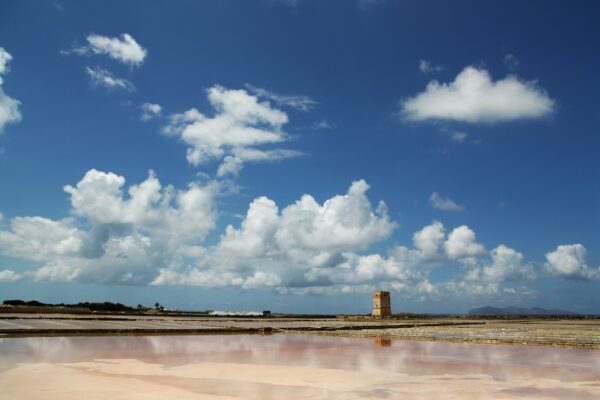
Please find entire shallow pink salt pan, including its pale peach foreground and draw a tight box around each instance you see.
[0,335,600,399]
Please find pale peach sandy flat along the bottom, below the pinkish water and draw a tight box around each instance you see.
[0,359,600,400]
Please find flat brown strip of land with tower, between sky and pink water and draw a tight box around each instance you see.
[0,313,600,350]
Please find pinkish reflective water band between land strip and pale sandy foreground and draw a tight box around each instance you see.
[0,335,600,380]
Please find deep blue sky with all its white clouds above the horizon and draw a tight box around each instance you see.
[0,0,600,314]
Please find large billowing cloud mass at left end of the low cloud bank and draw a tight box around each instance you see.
[0,170,219,285]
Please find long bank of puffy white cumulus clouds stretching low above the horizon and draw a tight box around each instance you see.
[0,169,552,300]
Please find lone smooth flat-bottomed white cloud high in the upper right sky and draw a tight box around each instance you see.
[400,66,555,123]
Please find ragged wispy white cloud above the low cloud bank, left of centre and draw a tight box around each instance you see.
[164,86,301,176]
